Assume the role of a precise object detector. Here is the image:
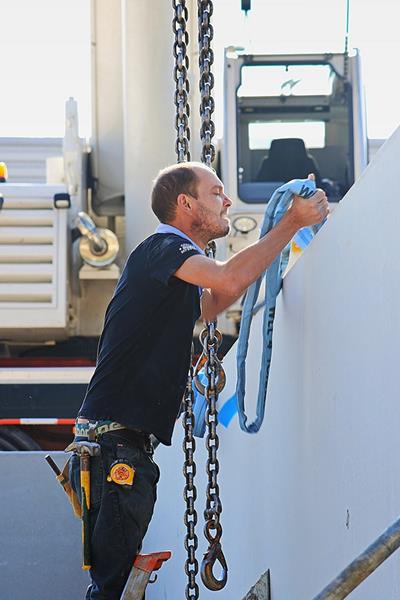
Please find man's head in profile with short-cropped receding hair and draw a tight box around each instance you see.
[151,162,232,243]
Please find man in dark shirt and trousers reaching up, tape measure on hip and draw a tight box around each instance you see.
[71,162,328,600]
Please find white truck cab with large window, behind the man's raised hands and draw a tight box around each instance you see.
[220,47,368,326]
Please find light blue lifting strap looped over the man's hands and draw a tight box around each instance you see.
[236,179,322,433]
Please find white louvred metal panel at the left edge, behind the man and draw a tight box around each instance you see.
[0,184,67,331]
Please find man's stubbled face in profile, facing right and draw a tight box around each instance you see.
[191,167,232,241]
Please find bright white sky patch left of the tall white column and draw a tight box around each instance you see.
[0,0,90,137]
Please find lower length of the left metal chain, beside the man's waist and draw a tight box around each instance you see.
[182,345,199,600]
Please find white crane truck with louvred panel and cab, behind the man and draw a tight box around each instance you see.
[0,2,378,450]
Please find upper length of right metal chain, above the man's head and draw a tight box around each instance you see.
[197,0,215,167]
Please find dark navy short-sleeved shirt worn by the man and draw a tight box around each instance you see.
[79,233,200,445]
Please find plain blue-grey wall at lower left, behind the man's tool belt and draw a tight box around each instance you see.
[0,452,89,600]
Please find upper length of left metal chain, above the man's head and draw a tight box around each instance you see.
[172,0,190,163]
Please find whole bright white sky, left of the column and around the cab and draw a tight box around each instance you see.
[0,0,400,138]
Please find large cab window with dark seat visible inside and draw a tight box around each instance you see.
[236,63,354,203]
